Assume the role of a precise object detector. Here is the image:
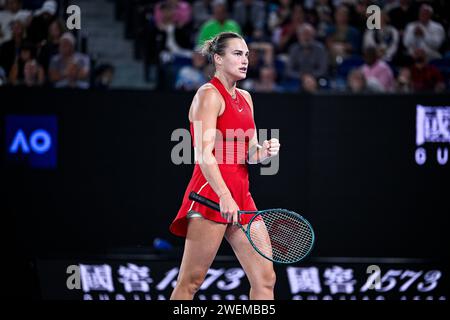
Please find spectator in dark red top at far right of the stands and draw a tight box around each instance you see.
[411,48,445,92]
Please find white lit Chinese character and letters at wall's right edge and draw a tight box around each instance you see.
[415,104,450,165]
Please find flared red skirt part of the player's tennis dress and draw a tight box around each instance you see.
[170,164,258,237]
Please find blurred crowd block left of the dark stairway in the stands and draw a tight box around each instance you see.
[0,0,113,89]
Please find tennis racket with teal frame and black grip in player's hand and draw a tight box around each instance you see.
[189,192,315,264]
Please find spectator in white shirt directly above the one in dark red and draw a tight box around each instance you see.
[403,4,445,60]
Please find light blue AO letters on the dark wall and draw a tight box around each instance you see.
[9,129,52,154]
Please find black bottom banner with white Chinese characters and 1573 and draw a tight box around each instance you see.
[37,257,449,301]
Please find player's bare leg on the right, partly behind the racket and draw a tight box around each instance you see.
[225,225,276,300]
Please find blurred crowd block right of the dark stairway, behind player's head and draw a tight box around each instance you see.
[137,0,450,93]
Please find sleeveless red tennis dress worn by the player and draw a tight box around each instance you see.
[170,77,257,237]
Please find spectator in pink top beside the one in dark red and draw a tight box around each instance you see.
[361,47,395,92]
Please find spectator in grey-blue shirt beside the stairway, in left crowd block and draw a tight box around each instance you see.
[49,32,90,88]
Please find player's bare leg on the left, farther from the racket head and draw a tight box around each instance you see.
[170,217,227,300]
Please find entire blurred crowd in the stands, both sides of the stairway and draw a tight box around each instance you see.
[0,0,450,93]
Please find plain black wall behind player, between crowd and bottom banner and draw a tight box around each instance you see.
[0,88,450,298]
